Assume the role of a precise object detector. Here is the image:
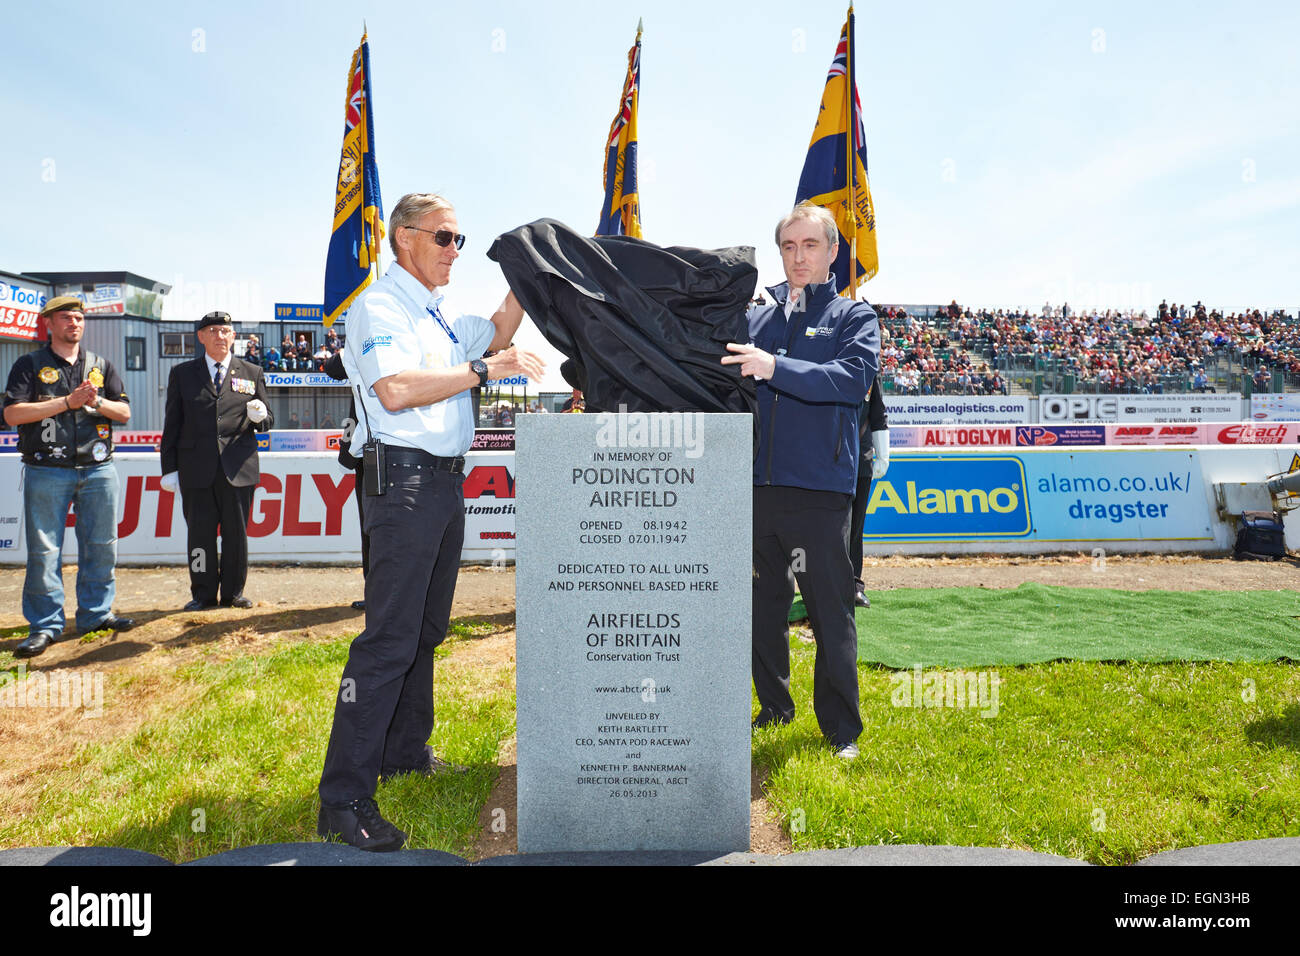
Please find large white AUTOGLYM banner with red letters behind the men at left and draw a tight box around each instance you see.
[0,451,515,564]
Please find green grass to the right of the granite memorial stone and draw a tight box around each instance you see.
[754,655,1300,864]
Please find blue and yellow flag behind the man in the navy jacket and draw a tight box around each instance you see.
[794,7,879,298]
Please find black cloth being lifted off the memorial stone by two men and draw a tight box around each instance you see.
[488,219,758,414]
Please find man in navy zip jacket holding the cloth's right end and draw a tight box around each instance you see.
[723,204,880,760]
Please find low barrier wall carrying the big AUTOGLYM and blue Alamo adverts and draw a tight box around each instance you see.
[0,444,1300,564]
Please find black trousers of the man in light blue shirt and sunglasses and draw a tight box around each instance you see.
[320,460,465,806]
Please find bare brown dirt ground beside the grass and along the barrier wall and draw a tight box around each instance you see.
[0,554,1300,857]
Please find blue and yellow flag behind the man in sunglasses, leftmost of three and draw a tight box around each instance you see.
[322,34,384,326]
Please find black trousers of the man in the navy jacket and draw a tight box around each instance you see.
[753,486,862,747]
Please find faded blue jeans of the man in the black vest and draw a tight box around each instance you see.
[22,462,117,635]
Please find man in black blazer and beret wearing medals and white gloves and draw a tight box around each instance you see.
[161,312,274,611]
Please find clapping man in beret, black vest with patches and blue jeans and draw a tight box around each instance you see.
[4,295,135,657]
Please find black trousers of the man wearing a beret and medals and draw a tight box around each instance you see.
[181,473,255,604]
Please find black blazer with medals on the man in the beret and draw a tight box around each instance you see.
[161,354,274,488]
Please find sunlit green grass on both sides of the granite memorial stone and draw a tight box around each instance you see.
[10,592,1300,864]
